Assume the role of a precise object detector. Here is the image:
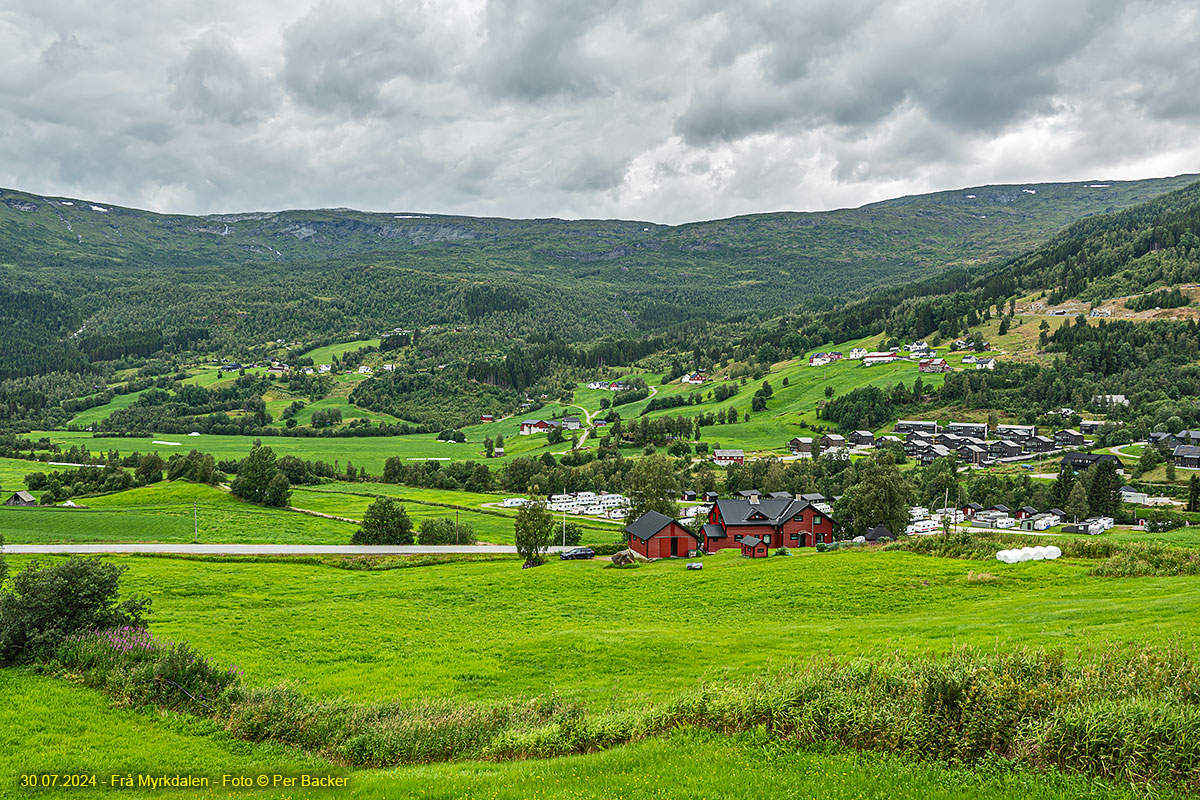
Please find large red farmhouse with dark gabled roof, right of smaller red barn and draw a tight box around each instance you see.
[704,498,834,553]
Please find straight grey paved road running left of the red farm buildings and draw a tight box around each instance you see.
[0,543,571,555]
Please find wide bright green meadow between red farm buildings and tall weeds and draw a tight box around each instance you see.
[10,551,1200,706]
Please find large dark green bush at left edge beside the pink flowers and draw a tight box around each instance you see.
[0,558,150,664]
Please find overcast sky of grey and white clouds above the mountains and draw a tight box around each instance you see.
[0,0,1200,222]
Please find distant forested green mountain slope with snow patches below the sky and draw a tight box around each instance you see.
[0,176,1195,341]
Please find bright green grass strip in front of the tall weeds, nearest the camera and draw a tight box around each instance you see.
[0,670,1152,800]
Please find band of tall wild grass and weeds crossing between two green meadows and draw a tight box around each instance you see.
[42,632,1200,788]
